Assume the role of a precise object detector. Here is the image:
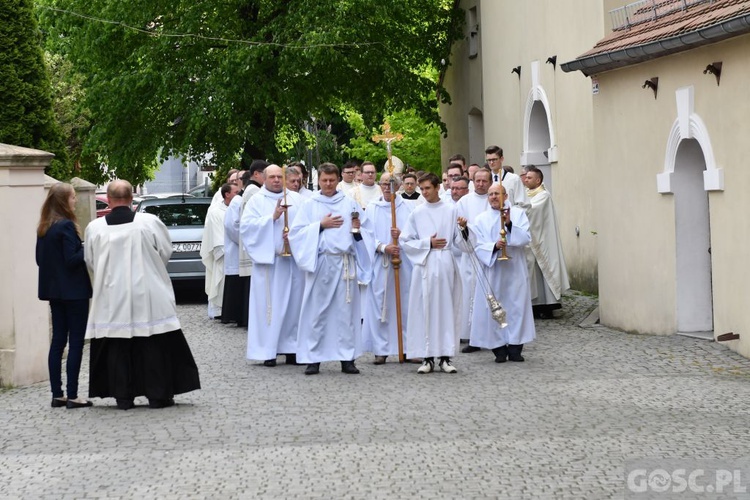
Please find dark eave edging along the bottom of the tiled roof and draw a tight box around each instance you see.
[560,13,750,76]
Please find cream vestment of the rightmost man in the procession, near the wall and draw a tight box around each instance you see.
[526,184,570,305]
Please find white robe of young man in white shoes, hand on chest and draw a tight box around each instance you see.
[401,201,461,358]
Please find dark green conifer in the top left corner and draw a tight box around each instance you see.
[0,0,66,179]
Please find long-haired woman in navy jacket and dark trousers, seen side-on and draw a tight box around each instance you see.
[36,183,92,408]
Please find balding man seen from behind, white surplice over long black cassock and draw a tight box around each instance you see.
[85,180,200,410]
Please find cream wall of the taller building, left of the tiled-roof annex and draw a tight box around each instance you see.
[443,0,604,291]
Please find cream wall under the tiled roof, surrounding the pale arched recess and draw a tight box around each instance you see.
[593,36,750,356]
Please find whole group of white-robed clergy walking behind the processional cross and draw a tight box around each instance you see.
[201,146,569,375]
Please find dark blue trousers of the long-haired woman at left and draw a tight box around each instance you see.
[47,299,89,399]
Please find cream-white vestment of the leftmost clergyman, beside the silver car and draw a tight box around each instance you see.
[200,200,227,319]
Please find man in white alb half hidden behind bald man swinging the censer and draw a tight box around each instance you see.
[456,168,492,353]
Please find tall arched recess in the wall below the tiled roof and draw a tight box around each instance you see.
[672,139,713,333]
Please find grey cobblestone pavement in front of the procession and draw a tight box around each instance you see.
[0,293,750,499]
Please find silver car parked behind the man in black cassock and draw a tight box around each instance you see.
[136,196,211,281]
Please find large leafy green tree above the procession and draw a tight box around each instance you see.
[39,0,463,182]
